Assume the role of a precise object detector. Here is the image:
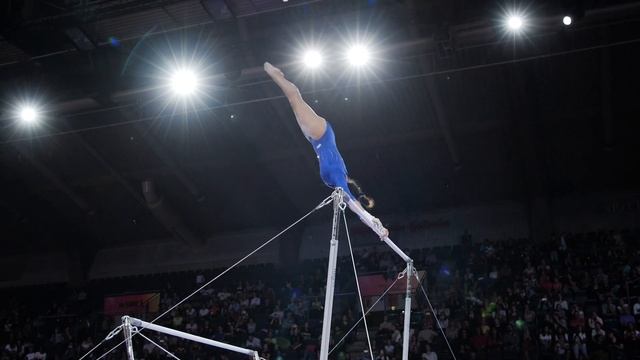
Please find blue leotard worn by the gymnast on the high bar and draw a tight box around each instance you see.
[307,122,356,200]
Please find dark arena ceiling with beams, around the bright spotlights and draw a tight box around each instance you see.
[0,0,640,252]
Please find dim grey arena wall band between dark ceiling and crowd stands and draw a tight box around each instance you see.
[0,194,640,287]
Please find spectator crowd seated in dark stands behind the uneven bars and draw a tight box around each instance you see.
[0,230,640,360]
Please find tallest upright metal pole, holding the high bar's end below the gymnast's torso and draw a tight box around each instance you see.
[320,188,345,360]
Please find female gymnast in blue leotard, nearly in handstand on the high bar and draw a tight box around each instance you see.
[264,62,389,238]
